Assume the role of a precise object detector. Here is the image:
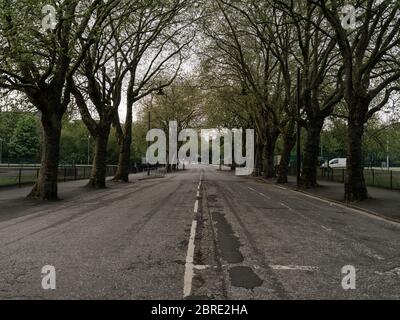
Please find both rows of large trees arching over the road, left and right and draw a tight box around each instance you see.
[0,0,400,201]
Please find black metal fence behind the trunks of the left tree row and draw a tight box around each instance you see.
[0,165,117,187]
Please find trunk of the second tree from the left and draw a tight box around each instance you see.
[87,129,109,189]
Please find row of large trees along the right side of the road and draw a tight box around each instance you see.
[200,0,400,201]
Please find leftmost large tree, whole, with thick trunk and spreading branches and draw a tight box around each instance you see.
[0,0,120,200]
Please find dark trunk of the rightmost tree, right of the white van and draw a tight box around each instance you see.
[345,116,368,202]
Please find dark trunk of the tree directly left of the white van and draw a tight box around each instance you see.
[301,119,324,188]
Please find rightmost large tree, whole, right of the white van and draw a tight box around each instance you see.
[308,0,400,201]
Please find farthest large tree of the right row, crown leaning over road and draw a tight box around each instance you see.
[203,0,283,178]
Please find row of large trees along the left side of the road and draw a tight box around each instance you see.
[0,0,200,200]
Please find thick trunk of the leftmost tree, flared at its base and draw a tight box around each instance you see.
[28,113,61,200]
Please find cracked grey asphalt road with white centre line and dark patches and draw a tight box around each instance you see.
[0,166,400,300]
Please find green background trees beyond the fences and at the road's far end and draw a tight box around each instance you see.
[0,107,400,167]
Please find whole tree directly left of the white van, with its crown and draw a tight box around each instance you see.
[280,1,343,188]
